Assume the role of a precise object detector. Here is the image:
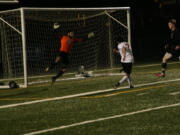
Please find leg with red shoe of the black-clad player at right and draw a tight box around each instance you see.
[156,52,173,77]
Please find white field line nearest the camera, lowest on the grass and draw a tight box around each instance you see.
[24,103,180,135]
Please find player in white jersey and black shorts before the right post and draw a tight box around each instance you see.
[113,41,134,88]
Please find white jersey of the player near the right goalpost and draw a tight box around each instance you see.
[118,42,134,63]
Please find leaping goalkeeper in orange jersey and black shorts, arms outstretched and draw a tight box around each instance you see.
[45,23,94,84]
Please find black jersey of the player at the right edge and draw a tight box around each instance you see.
[166,29,180,54]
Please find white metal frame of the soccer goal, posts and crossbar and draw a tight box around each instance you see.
[0,7,131,88]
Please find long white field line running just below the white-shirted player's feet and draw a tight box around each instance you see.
[0,79,180,109]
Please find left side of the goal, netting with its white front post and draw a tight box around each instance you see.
[0,9,27,88]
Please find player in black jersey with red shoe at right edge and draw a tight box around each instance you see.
[156,19,180,77]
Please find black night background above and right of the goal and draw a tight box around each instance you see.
[0,0,180,62]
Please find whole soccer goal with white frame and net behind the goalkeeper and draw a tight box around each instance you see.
[0,7,131,87]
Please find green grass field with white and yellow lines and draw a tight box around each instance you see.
[0,62,180,135]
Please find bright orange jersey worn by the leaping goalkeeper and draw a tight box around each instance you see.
[60,36,82,53]
